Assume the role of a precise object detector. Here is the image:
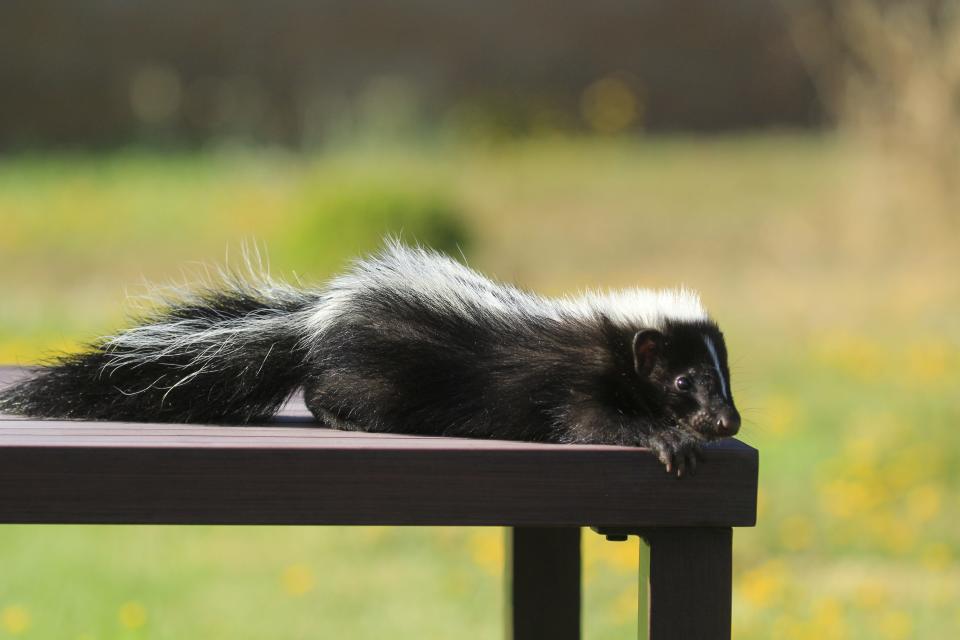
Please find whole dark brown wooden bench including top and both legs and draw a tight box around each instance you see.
[0,368,758,640]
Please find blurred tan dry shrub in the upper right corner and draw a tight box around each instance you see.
[785,0,960,246]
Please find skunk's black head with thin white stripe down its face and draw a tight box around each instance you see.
[633,321,740,440]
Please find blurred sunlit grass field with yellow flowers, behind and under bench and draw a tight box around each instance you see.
[0,134,960,640]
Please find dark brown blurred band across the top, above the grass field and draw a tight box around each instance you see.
[0,0,818,146]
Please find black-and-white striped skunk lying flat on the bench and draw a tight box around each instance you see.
[0,241,740,475]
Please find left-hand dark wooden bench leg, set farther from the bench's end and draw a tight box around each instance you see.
[507,527,580,640]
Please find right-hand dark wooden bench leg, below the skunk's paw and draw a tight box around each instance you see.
[640,527,733,640]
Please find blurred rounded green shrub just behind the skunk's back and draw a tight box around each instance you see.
[272,175,471,277]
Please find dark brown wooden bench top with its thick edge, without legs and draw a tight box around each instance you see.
[0,367,758,527]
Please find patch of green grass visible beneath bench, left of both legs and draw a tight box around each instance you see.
[0,527,500,638]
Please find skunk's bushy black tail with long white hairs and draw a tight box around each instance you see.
[0,276,316,423]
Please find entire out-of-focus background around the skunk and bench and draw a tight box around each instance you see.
[0,0,960,640]
